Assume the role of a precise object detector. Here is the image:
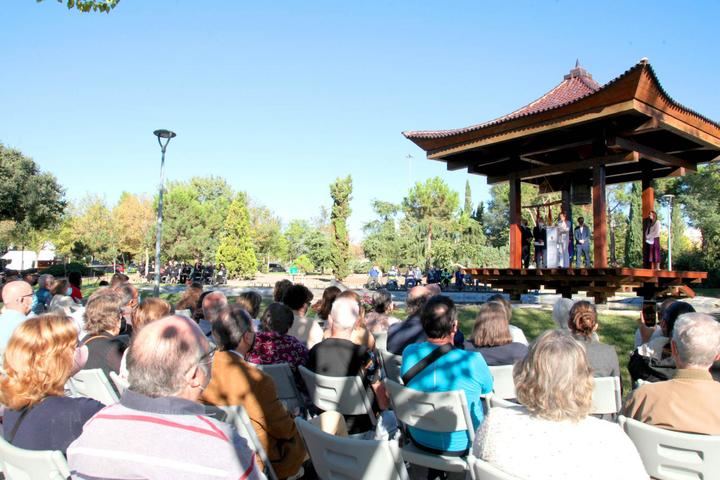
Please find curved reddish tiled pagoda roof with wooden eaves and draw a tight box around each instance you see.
[403,59,720,183]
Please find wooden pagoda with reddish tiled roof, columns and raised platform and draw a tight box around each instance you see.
[403,59,720,301]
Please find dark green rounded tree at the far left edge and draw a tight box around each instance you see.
[0,144,67,243]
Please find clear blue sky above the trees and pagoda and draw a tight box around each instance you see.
[0,0,720,241]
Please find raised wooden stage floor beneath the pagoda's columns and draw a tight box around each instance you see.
[463,267,707,303]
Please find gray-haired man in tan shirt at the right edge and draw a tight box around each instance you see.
[623,313,720,435]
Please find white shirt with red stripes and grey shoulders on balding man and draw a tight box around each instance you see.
[67,390,265,480]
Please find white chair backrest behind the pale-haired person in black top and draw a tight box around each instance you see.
[299,366,376,425]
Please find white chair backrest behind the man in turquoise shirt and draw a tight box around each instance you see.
[385,379,475,443]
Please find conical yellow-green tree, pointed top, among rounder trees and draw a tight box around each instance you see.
[216,193,257,278]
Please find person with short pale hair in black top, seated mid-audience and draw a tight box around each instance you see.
[307,297,388,434]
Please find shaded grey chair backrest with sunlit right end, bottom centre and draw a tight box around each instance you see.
[295,418,409,480]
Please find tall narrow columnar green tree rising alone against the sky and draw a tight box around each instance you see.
[330,175,352,280]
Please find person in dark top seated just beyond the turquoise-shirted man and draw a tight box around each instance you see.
[387,284,465,355]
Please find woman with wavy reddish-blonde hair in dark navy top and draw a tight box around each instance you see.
[0,313,103,454]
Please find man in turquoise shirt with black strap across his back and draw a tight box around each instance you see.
[401,295,493,455]
